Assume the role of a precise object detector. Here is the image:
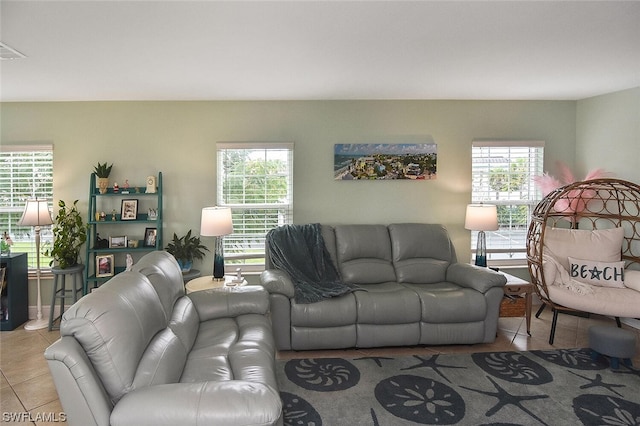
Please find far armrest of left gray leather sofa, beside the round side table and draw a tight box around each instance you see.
[187,285,269,321]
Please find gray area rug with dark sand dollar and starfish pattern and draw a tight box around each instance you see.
[277,349,640,426]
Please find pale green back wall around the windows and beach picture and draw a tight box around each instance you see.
[0,101,580,305]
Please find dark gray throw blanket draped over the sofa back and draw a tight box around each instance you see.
[267,223,354,303]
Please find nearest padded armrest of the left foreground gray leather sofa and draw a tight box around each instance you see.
[111,380,282,426]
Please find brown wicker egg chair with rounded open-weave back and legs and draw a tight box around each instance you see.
[527,179,640,344]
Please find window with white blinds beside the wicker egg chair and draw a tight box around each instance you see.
[471,141,544,265]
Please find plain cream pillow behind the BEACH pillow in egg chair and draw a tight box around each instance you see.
[543,226,624,271]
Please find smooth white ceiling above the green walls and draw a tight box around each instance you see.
[0,0,640,101]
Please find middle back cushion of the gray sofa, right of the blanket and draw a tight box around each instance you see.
[335,225,396,285]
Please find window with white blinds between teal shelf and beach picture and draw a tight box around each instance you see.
[217,143,293,271]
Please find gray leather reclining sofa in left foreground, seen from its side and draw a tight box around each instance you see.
[45,251,282,426]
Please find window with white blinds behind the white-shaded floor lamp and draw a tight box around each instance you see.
[0,145,53,268]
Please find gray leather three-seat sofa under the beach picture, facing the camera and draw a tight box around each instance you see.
[261,223,506,350]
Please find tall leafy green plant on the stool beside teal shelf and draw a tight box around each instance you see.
[45,200,87,269]
